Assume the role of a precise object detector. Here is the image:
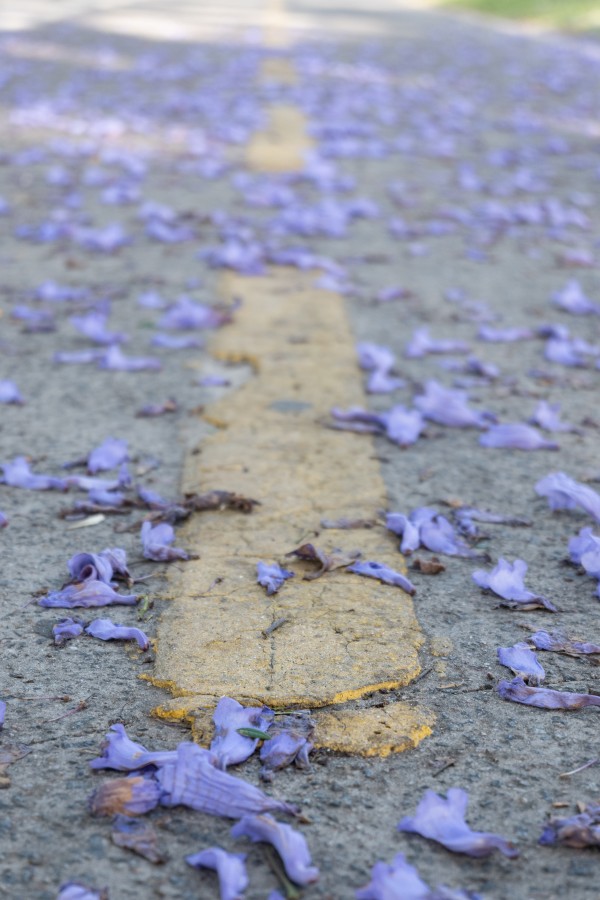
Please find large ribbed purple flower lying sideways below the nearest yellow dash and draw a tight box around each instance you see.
[156,741,297,819]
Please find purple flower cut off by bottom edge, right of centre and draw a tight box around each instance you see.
[355,853,481,900]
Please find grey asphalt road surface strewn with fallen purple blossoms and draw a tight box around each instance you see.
[0,3,600,900]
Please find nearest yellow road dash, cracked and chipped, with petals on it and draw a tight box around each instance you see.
[150,269,431,752]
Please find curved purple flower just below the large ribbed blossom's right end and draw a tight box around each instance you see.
[231,814,319,884]
